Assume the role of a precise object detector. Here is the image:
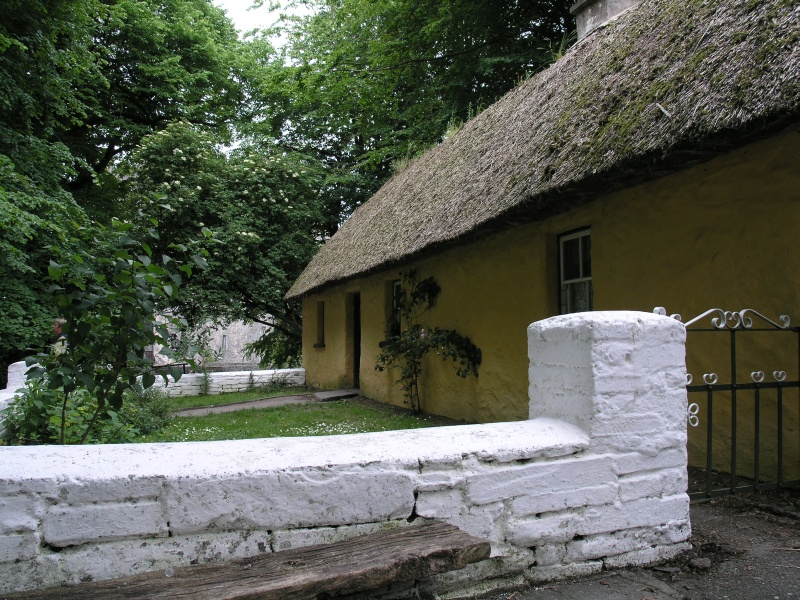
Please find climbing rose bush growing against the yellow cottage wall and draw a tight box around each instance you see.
[375,270,481,412]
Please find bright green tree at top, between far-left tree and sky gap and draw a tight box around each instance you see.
[61,0,244,222]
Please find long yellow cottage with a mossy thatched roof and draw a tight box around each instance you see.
[287,0,800,477]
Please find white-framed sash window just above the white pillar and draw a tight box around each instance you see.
[558,229,592,315]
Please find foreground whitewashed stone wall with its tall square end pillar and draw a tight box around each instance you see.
[0,312,690,594]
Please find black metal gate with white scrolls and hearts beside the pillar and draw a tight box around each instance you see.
[653,307,800,499]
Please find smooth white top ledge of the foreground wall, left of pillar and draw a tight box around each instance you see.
[0,418,589,478]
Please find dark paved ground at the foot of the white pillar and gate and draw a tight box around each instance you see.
[456,491,800,600]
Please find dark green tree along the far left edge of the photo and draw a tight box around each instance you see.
[0,0,99,385]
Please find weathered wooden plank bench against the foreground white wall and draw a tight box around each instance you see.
[6,521,490,600]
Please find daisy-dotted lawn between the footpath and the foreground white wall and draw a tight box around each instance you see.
[137,396,463,442]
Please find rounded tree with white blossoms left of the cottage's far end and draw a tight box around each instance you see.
[122,122,325,360]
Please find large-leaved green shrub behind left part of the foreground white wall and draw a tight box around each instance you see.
[5,221,205,444]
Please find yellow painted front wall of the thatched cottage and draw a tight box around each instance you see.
[303,128,800,478]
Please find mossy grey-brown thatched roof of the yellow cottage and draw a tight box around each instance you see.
[287,0,800,298]
